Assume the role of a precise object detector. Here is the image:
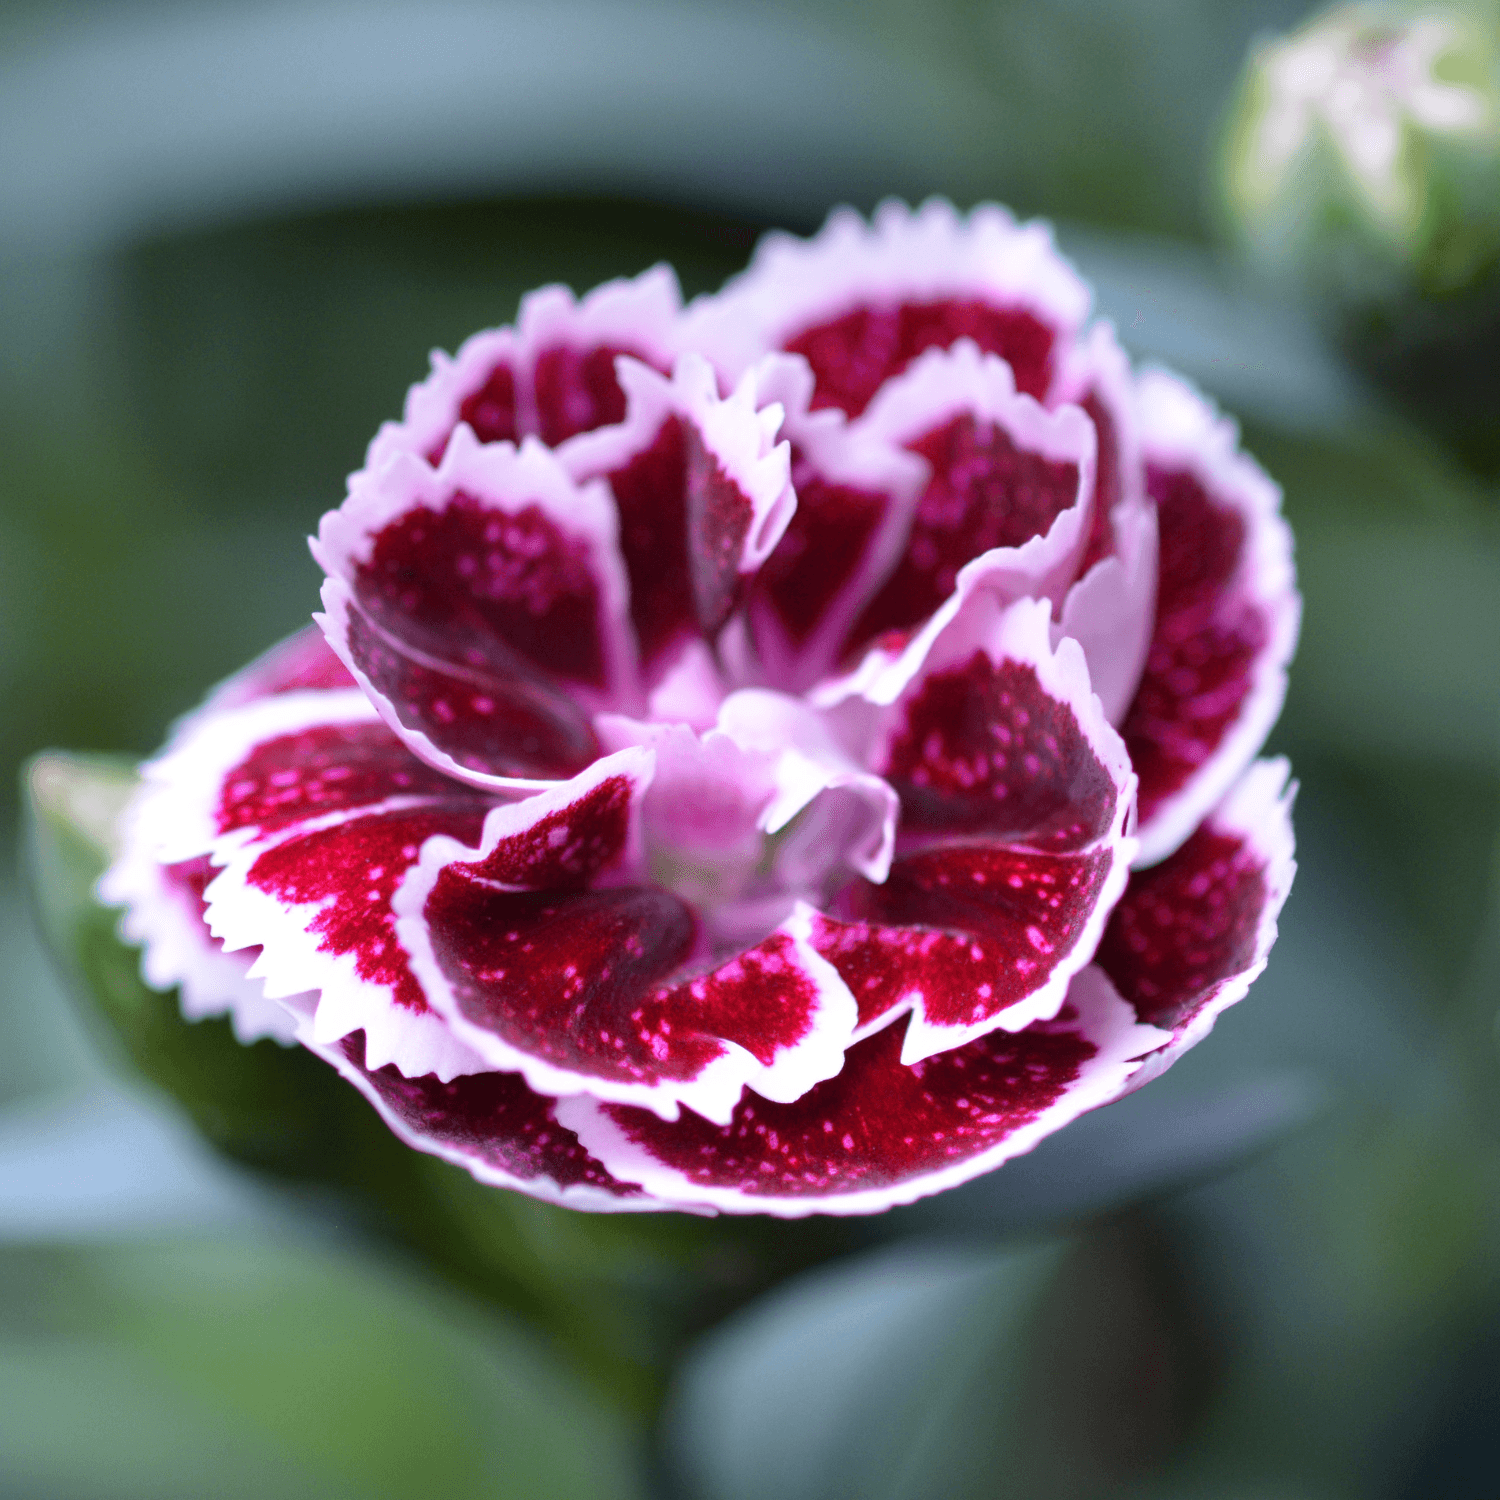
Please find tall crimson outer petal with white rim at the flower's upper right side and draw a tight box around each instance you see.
[1122,371,1302,866]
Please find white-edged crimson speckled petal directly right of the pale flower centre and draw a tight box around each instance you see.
[816,593,1136,1062]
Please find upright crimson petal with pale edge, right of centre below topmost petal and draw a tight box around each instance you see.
[849,342,1095,645]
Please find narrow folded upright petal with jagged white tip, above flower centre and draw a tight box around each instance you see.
[560,354,797,687]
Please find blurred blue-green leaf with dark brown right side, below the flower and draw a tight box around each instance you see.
[668,1220,1208,1500]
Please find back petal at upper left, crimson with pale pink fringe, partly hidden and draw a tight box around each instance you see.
[365,266,681,473]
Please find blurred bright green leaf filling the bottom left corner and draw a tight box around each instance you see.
[0,1244,642,1500]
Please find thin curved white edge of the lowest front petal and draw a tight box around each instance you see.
[557,969,1166,1218]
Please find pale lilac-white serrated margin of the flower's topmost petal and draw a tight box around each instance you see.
[681,198,1089,399]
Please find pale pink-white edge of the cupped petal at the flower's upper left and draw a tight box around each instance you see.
[309,426,645,795]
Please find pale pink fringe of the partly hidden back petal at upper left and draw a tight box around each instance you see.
[365,266,683,473]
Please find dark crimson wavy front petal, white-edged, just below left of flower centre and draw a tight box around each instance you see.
[395,762,855,1119]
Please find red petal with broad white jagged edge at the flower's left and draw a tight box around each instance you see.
[117,690,489,1077]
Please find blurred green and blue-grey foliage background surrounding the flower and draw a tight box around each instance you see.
[0,0,1500,1500]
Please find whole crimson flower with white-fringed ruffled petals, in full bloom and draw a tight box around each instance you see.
[102,203,1299,1217]
